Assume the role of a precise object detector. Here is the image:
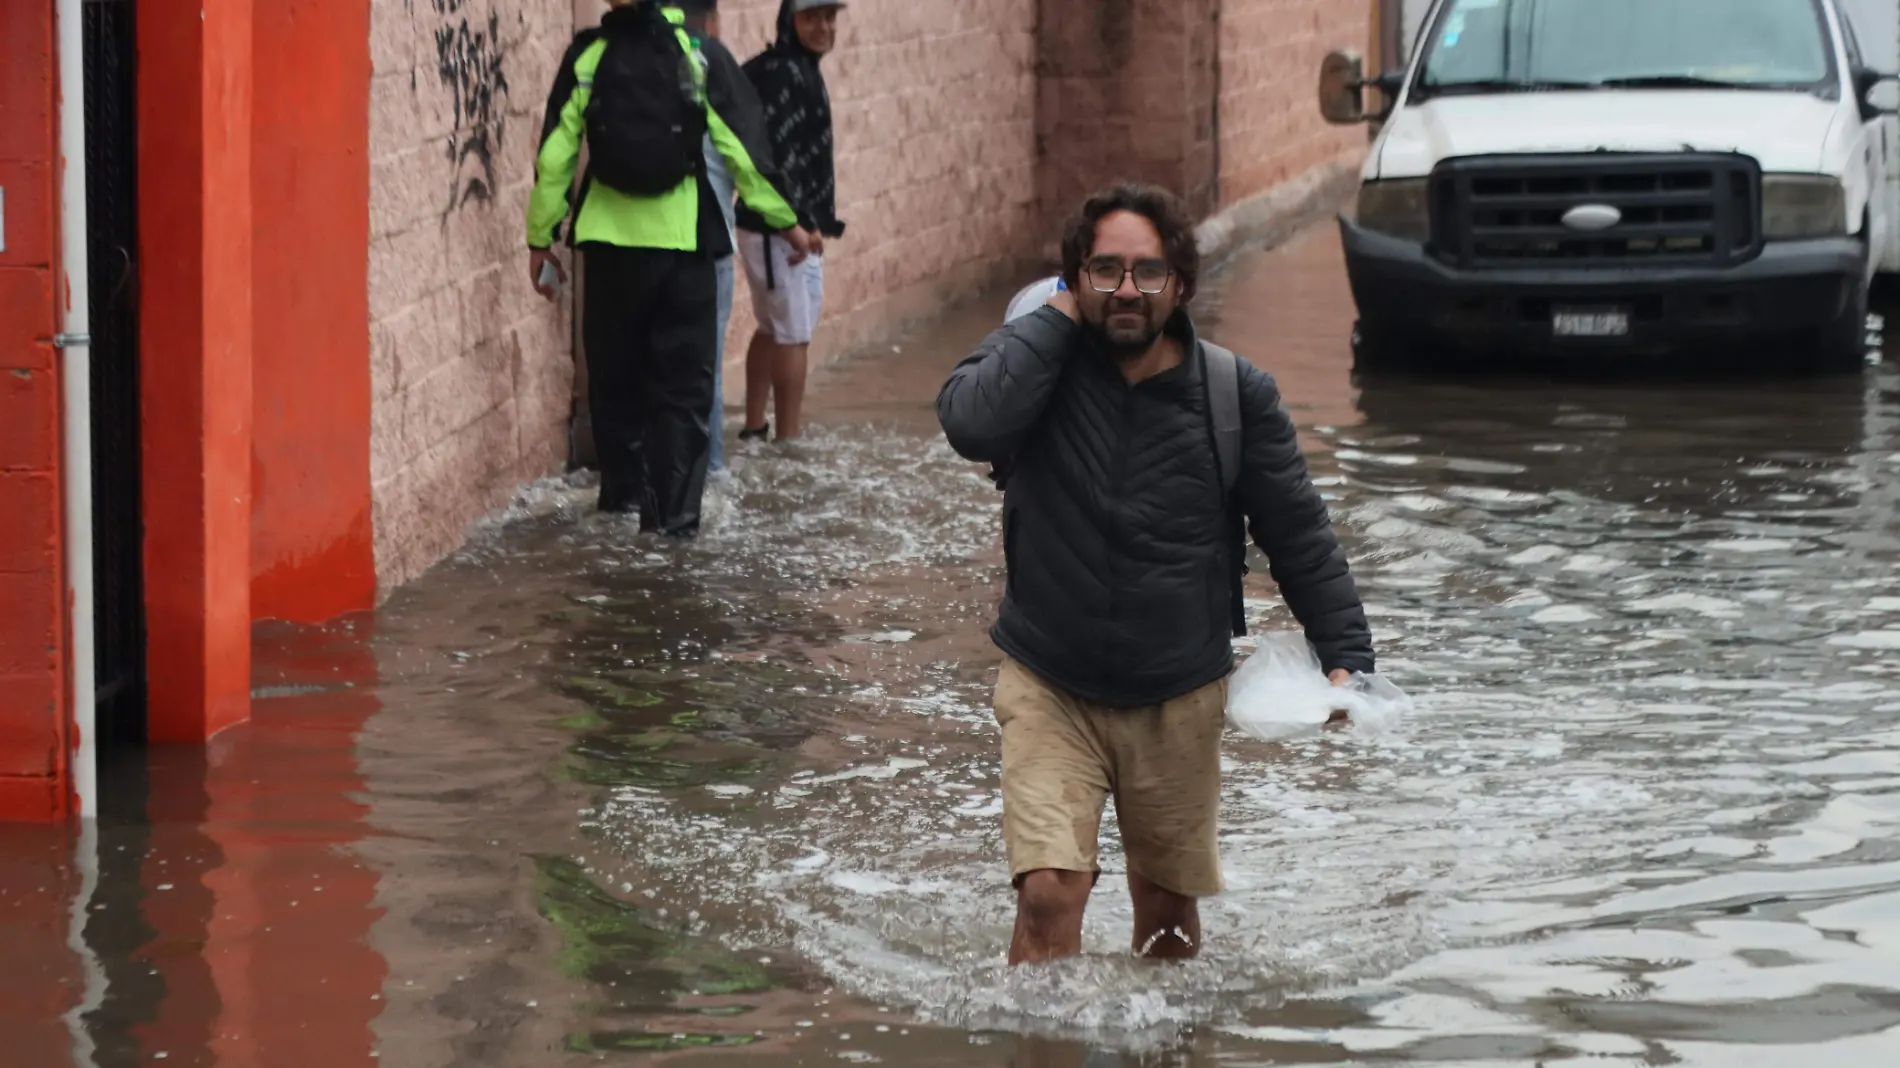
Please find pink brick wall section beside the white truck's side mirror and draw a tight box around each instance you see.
[1220,0,1372,205]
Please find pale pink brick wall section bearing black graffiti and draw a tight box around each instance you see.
[369,0,574,589]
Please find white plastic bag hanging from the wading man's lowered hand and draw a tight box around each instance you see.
[1227,633,1412,741]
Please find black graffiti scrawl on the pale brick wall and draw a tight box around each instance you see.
[428,0,509,217]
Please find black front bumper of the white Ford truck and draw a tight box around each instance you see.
[1340,217,1866,355]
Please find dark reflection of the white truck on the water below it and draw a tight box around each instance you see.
[1334,368,1881,513]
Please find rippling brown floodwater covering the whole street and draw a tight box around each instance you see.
[0,228,1900,1068]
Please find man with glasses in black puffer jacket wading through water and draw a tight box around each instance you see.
[937,184,1374,963]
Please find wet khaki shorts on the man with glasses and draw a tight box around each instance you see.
[996,659,1227,897]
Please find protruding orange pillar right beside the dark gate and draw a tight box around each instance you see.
[139,0,253,741]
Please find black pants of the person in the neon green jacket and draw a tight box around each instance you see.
[581,243,718,536]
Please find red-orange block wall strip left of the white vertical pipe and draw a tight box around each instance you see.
[0,0,68,819]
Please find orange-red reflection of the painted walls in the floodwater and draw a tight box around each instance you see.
[0,627,386,1068]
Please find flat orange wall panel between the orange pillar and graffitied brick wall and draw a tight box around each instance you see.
[251,0,376,623]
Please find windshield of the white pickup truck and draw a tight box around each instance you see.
[1417,0,1834,95]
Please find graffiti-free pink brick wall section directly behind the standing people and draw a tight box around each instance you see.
[703,0,1037,391]
